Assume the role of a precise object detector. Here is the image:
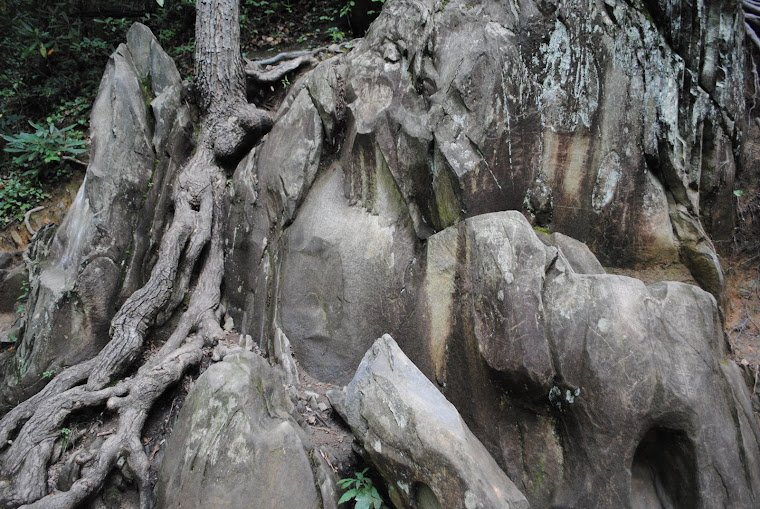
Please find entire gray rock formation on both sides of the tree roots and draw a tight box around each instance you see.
[0,0,760,508]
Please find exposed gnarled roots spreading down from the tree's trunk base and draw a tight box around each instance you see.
[0,155,225,508]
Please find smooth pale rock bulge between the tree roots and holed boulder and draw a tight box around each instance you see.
[225,69,419,384]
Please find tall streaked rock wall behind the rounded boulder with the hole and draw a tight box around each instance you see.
[226,0,744,383]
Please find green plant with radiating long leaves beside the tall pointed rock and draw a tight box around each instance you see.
[0,120,86,177]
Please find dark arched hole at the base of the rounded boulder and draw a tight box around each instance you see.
[631,428,699,509]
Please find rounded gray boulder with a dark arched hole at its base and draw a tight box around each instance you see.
[412,212,760,507]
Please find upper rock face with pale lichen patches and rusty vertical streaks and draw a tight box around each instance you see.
[336,0,743,286]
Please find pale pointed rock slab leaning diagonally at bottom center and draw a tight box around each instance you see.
[345,335,529,509]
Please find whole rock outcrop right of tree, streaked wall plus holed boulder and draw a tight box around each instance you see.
[211,0,760,507]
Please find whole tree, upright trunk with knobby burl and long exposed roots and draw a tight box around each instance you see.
[0,0,272,508]
